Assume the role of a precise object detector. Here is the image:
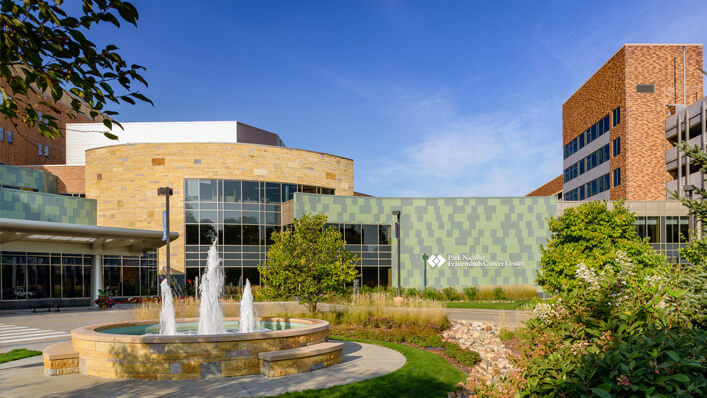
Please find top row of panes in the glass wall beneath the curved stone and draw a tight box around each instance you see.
[184,179,334,204]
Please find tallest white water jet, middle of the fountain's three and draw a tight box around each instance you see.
[198,242,226,334]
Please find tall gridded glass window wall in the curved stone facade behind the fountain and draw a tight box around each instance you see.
[184,179,336,291]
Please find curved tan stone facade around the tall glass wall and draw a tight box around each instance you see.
[85,143,353,273]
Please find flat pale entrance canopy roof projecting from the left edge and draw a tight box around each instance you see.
[0,218,179,254]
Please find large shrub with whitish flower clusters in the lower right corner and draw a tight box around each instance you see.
[468,252,707,397]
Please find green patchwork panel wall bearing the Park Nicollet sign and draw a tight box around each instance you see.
[294,193,557,288]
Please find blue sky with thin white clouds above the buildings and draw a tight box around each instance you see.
[88,0,707,196]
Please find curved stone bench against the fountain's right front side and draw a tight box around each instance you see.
[258,343,344,377]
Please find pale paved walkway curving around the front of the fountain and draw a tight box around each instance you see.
[0,341,405,398]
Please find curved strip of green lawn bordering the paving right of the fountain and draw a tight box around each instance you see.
[279,336,466,398]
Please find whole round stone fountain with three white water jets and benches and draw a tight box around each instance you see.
[55,239,343,380]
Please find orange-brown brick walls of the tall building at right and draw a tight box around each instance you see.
[562,44,703,200]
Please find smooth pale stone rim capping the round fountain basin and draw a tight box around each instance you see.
[71,317,329,344]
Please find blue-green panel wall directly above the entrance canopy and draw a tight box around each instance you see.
[0,188,96,225]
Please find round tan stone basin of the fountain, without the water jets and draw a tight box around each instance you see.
[71,318,334,380]
